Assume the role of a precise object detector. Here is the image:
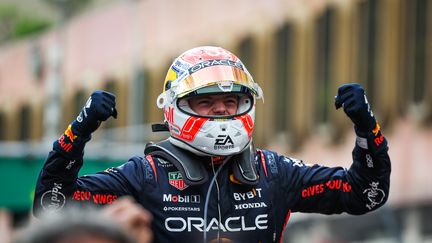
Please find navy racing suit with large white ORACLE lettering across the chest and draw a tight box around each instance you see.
[34,127,390,242]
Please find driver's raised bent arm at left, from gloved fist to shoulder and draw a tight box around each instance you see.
[33,91,145,216]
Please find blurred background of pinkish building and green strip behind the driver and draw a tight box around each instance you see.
[0,0,432,243]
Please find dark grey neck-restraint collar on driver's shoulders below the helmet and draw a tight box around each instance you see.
[144,139,259,185]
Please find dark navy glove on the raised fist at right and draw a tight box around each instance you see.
[335,83,377,137]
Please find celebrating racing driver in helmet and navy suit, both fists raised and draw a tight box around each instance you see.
[34,46,390,242]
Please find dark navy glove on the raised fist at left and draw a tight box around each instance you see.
[72,90,117,136]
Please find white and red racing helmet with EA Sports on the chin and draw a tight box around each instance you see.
[157,46,263,156]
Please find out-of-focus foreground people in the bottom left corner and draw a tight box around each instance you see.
[0,197,153,243]
